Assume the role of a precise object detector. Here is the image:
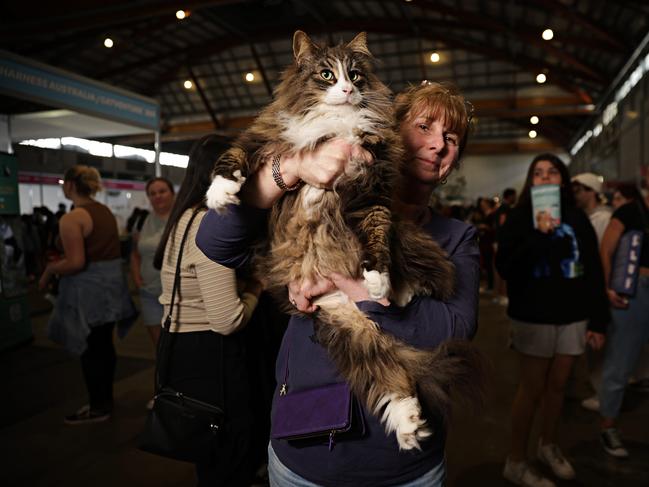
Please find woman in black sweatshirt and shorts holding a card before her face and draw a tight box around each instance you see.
[496,154,610,487]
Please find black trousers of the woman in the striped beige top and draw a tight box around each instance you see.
[167,331,255,487]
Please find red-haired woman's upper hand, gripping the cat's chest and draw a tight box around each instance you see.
[281,139,373,188]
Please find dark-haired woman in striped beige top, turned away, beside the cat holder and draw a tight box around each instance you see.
[154,136,262,487]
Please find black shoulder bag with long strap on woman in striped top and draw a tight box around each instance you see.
[139,212,225,463]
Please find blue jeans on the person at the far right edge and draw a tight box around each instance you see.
[599,276,649,418]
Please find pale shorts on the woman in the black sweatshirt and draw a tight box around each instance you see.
[511,320,587,358]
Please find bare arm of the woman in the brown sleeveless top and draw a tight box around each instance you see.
[39,210,92,289]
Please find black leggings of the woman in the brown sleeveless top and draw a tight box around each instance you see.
[81,323,117,411]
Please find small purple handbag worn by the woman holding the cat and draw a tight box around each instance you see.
[270,353,365,451]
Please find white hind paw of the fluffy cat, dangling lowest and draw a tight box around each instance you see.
[379,394,433,450]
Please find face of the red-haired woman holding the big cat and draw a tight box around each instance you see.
[401,110,460,185]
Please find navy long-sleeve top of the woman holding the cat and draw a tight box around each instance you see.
[196,205,479,487]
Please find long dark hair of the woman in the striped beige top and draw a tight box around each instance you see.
[153,135,223,269]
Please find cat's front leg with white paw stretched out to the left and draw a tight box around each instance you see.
[205,148,246,212]
